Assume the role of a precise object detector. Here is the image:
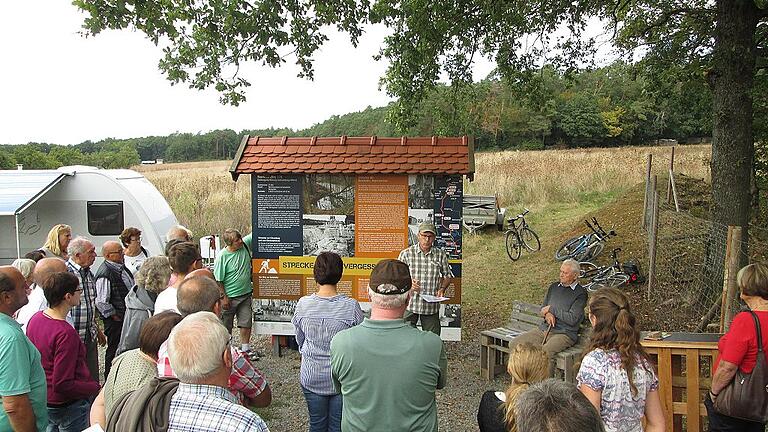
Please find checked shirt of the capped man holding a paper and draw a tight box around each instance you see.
[397,243,453,315]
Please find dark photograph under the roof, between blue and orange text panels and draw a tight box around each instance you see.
[303,174,355,215]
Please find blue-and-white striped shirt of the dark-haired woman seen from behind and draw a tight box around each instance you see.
[292,294,363,395]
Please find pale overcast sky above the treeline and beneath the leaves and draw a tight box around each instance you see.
[0,0,498,144]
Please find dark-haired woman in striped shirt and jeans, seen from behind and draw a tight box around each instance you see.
[292,252,363,432]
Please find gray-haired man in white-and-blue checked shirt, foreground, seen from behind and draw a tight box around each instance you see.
[168,312,269,432]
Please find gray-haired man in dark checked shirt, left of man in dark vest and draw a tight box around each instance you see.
[67,237,107,381]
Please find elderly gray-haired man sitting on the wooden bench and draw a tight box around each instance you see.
[511,259,587,359]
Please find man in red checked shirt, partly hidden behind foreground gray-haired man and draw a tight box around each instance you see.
[157,271,272,408]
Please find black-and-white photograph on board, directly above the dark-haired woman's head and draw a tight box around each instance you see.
[302,214,355,257]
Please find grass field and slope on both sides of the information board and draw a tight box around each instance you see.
[136,145,711,332]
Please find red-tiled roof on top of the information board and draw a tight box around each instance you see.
[229,135,475,180]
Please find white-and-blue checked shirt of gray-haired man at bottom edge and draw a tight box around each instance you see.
[168,383,269,432]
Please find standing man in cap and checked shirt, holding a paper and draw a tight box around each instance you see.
[397,222,453,336]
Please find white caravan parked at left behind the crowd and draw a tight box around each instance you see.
[0,166,178,264]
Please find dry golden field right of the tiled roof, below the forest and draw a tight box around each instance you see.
[464,145,712,209]
